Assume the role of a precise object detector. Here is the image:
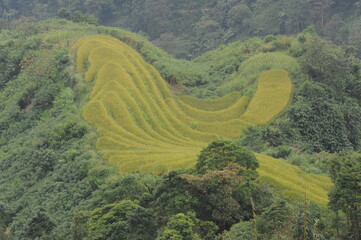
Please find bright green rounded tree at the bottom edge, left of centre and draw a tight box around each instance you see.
[73,200,157,240]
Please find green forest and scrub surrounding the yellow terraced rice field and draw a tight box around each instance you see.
[0,0,361,240]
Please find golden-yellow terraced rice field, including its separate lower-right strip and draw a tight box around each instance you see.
[72,35,330,204]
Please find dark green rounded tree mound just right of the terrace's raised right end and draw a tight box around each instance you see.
[289,81,352,152]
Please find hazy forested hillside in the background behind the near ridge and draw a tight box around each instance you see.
[0,0,361,59]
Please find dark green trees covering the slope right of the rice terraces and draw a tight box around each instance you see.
[233,28,361,154]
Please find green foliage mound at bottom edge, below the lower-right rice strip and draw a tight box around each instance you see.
[221,198,337,240]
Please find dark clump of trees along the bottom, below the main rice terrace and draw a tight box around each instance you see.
[66,140,257,240]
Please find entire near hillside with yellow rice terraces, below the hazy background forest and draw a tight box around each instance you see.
[0,20,361,239]
